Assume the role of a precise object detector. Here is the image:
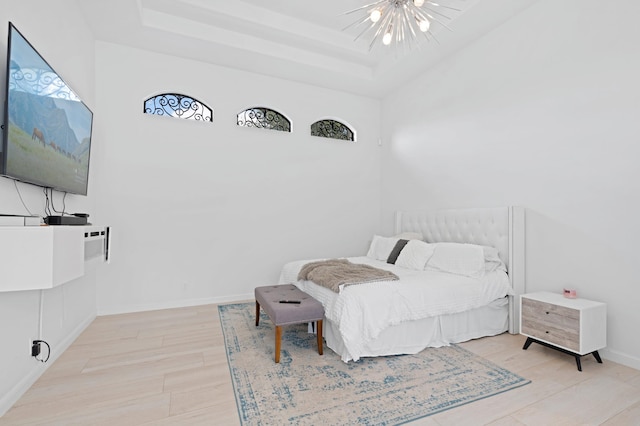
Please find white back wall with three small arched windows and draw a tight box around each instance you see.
[93,42,380,314]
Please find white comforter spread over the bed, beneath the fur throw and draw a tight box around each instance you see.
[280,257,512,360]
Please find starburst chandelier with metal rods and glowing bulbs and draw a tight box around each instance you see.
[344,0,460,51]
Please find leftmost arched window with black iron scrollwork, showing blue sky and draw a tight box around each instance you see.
[144,93,213,121]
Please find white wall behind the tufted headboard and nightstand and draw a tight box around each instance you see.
[382,0,640,368]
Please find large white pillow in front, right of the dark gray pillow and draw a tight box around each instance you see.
[425,243,485,278]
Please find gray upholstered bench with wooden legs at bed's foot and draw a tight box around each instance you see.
[255,284,324,362]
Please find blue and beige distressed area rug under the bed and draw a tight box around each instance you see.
[218,303,530,426]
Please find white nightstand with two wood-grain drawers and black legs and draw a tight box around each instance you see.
[520,292,607,371]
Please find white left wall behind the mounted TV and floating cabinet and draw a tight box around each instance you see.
[0,0,96,415]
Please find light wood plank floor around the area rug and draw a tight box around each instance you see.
[0,305,640,426]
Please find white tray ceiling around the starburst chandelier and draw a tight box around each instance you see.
[78,0,537,98]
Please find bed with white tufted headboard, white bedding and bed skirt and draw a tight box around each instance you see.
[279,207,525,362]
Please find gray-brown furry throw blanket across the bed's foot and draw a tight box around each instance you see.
[298,259,398,293]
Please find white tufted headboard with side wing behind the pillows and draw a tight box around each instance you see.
[396,207,525,334]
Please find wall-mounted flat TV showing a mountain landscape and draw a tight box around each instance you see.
[0,22,93,195]
